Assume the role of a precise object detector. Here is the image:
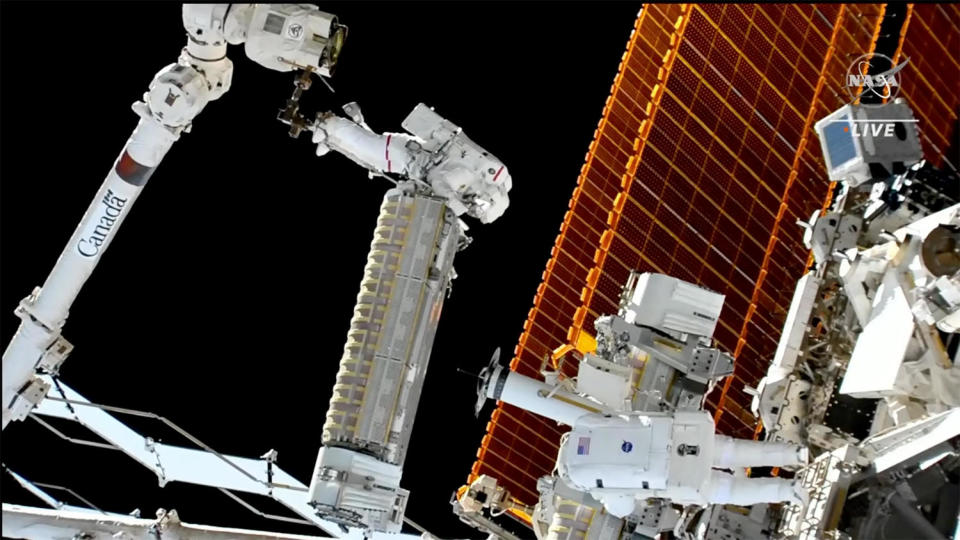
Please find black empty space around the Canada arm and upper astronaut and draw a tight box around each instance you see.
[0,2,640,538]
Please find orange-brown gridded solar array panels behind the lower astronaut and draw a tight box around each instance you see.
[468,4,960,520]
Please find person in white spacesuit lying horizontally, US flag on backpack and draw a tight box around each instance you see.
[557,411,808,517]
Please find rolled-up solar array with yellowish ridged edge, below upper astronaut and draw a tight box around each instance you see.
[323,188,460,465]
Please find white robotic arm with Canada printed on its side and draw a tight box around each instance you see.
[0,4,346,429]
